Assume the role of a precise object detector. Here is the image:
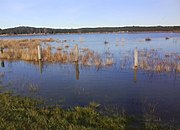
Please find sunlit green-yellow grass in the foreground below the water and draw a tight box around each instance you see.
[0,93,178,130]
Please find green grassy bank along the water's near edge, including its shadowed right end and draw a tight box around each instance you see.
[0,92,180,130]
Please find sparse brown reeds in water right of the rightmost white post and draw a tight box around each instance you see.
[139,49,180,72]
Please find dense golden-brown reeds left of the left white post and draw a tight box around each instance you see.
[0,38,53,61]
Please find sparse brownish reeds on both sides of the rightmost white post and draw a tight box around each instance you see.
[120,49,180,73]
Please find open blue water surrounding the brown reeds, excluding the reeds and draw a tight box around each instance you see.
[0,33,180,122]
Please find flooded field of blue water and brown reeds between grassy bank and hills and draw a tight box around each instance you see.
[0,33,180,123]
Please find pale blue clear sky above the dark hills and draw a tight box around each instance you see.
[0,0,180,29]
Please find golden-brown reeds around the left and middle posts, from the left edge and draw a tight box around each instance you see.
[0,39,113,68]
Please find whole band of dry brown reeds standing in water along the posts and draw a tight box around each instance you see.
[0,38,180,72]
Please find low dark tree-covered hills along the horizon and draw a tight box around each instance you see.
[0,26,180,35]
